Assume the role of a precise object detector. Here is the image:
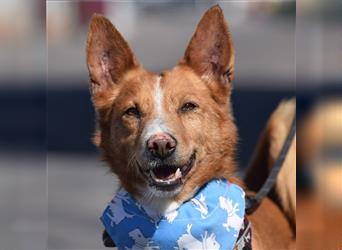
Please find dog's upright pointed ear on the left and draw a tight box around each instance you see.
[86,14,138,97]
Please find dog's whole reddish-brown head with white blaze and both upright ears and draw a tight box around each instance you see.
[87,7,237,201]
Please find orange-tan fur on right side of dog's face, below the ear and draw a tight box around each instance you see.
[164,65,237,200]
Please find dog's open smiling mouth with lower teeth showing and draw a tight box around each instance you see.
[139,152,196,191]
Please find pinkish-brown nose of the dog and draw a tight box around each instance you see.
[147,133,177,158]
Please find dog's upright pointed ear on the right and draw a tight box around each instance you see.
[184,5,234,85]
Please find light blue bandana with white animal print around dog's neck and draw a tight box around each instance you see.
[101,179,245,250]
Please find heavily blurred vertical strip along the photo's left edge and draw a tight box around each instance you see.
[0,0,48,250]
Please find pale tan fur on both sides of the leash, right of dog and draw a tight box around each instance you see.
[246,100,296,228]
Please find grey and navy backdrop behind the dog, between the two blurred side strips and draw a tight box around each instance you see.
[47,1,296,249]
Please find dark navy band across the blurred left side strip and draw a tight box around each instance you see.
[0,83,47,151]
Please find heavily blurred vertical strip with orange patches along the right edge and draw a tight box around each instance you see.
[296,0,342,250]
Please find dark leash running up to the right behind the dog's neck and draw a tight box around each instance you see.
[245,115,296,214]
